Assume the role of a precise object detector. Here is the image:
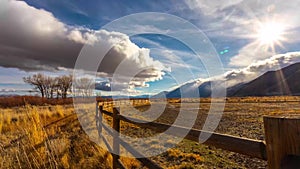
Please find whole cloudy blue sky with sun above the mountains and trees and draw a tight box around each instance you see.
[0,0,300,95]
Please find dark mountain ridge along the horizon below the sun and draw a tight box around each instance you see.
[152,63,300,98]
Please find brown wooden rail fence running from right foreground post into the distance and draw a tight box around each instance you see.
[96,100,300,169]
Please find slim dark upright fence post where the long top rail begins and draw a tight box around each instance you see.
[112,107,120,169]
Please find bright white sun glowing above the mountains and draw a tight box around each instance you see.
[256,22,285,49]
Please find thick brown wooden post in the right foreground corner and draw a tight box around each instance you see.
[264,116,300,169]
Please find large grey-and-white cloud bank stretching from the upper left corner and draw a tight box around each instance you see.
[0,0,165,90]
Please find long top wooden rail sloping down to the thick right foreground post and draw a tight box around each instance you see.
[120,115,267,160]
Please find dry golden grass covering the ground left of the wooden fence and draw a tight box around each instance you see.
[0,105,109,168]
